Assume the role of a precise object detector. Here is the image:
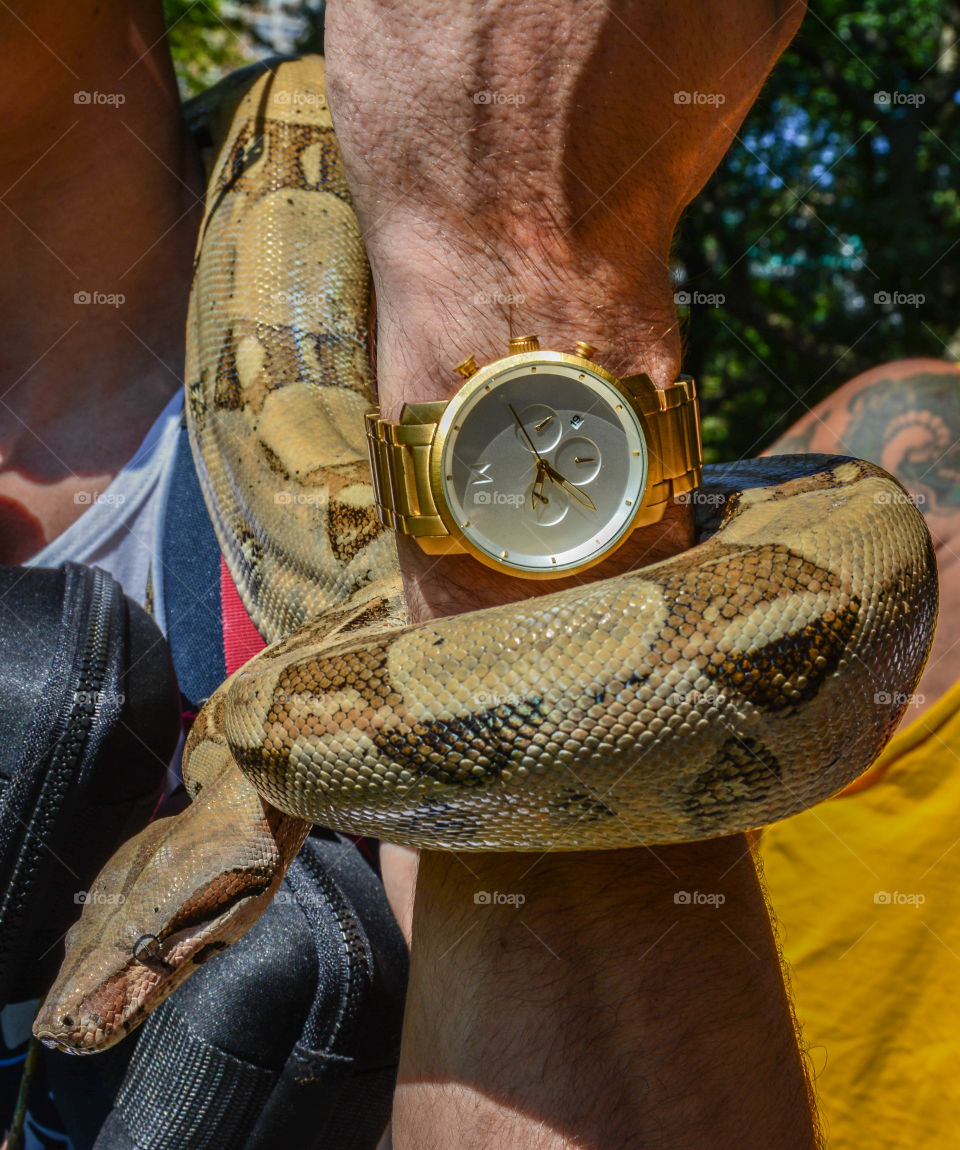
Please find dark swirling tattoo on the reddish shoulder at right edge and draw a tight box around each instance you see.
[840,370,960,509]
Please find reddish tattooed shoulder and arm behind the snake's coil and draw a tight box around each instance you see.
[767,359,960,718]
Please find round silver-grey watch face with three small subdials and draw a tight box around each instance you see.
[435,353,647,577]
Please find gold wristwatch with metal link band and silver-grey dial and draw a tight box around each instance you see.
[366,336,702,578]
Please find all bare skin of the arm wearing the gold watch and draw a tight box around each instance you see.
[327,0,816,1150]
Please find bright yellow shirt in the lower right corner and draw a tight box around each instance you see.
[760,683,960,1150]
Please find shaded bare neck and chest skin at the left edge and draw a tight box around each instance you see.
[0,0,203,561]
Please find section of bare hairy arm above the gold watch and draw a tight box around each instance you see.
[328,0,799,417]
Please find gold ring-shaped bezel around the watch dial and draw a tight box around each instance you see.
[430,350,656,580]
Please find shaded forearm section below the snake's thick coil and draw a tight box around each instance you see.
[394,836,816,1150]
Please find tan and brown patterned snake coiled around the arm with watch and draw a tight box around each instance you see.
[34,58,938,1053]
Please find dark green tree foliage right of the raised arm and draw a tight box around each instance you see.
[676,0,960,459]
